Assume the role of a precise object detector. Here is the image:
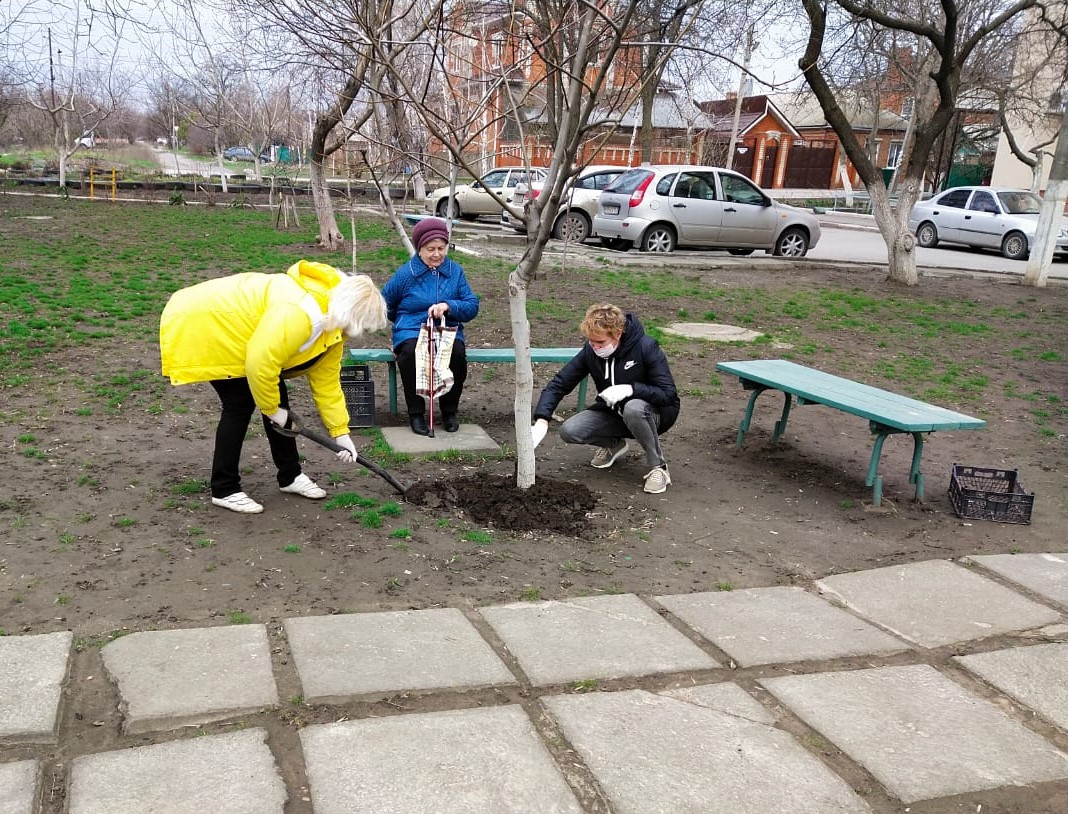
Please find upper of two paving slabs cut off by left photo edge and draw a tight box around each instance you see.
[0,630,74,742]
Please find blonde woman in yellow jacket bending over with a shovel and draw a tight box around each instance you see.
[159,260,387,514]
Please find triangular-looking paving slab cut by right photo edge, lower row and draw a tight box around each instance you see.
[955,644,1068,732]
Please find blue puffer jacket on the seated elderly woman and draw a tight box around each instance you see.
[382,255,478,347]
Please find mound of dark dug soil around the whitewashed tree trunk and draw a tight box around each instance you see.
[405,475,597,536]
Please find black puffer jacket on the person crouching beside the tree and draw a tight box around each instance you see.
[534,314,679,434]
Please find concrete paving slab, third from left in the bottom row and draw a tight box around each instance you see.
[300,706,582,814]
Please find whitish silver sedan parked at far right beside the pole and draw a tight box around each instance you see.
[909,187,1068,260]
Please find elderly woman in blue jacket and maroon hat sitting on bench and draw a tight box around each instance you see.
[382,218,478,435]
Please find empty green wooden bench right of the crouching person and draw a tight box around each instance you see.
[716,359,987,506]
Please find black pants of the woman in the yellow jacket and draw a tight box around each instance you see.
[210,378,300,498]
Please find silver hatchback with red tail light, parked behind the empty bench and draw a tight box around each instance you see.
[593,165,820,257]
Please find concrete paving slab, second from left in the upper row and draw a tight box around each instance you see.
[100,625,278,733]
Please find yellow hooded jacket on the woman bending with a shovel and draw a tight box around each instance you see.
[159,260,348,437]
